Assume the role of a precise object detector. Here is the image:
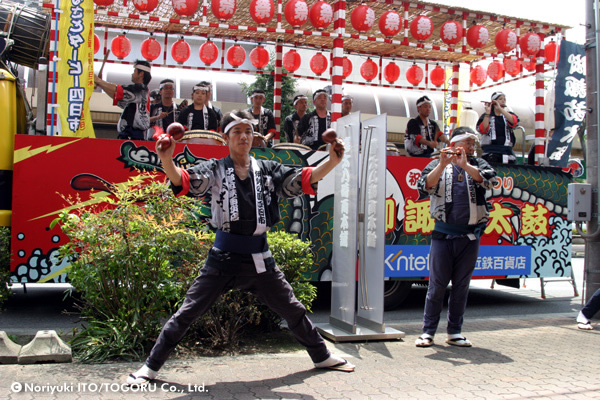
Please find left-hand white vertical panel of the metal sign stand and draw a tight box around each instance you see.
[329,112,358,333]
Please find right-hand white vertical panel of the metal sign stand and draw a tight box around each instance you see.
[357,114,387,332]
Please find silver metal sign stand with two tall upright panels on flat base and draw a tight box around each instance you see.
[317,113,405,342]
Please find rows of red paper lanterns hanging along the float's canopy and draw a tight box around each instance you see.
[94,0,560,87]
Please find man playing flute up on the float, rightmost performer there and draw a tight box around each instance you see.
[477,92,519,164]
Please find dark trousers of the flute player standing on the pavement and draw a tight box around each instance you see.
[423,237,479,336]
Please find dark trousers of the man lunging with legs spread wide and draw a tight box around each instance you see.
[146,255,330,371]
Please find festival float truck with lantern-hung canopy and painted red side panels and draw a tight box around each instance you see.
[0,0,585,307]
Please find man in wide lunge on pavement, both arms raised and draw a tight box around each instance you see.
[127,111,354,386]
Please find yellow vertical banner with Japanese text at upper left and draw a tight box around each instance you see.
[57,0,95,138]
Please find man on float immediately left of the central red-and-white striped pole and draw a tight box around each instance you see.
[298,89,331,150]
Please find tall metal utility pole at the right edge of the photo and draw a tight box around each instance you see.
[583,0,600,301]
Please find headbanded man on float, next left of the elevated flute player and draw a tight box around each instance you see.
[404,96,450,157]
